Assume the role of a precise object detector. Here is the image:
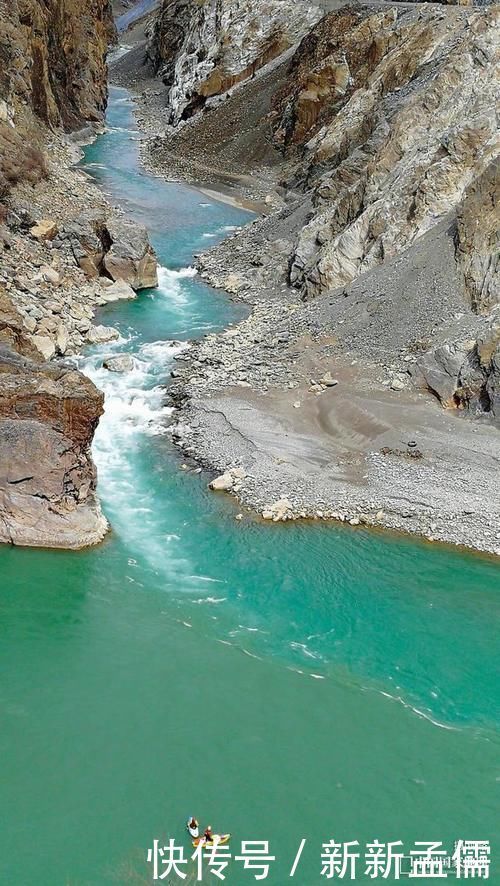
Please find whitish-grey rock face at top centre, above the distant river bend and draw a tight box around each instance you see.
[148,0,320,125]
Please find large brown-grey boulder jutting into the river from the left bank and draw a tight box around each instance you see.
[103,217,158,289]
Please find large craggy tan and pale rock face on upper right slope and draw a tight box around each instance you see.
[274,5,499,301]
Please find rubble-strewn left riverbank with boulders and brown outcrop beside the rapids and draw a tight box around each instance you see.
[0,93,157,549]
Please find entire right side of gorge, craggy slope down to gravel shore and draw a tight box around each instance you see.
[112,3,500,554]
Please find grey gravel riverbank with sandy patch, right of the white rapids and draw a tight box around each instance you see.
[105,31,500,554]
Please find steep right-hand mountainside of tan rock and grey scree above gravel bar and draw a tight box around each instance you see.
[143,3,500,434]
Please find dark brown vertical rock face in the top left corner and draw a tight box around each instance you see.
[0,0,114,129]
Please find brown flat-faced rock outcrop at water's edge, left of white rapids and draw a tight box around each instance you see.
[0,293,107,548]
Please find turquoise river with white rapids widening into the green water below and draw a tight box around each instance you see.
[0,90,500,886]
